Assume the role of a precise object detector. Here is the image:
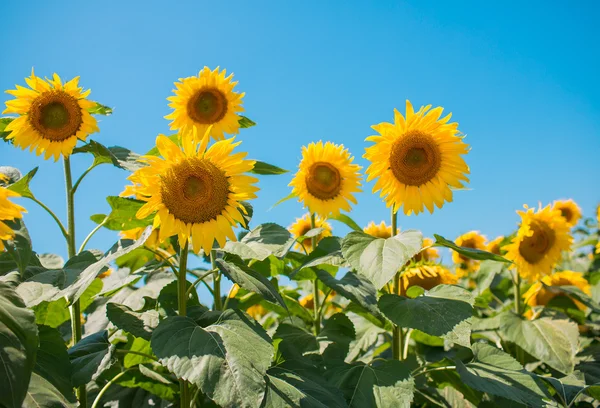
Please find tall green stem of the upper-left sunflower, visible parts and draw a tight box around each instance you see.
[64,157,87,407]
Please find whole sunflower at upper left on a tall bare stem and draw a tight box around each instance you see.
[2,70,99,161]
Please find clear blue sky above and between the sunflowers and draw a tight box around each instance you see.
[0,0,600,266]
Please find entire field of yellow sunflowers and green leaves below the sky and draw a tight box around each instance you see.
[0,67,600,408]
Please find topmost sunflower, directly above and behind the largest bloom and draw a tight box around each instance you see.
[165,67,244,140]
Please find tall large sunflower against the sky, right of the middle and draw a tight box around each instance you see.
[364,101,469,215]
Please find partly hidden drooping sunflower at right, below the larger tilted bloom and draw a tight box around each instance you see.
[523,271,591,317]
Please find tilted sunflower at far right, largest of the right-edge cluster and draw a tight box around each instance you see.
[504,205,573,281]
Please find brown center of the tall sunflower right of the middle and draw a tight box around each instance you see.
[390,130,442,186]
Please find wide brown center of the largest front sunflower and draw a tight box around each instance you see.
[160,158,229,224]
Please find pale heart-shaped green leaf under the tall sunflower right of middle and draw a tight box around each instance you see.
[342,230,423,290]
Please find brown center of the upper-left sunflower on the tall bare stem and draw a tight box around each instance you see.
[29,90,83,142]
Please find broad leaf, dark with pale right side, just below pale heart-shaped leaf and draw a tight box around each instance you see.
[378,285,474,347]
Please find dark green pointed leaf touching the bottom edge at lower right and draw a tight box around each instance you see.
[456,343,549,407]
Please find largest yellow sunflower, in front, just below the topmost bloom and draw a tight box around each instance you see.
[124,129,258,253]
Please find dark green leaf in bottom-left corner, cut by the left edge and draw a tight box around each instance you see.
[0,282,38,408]
